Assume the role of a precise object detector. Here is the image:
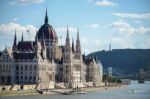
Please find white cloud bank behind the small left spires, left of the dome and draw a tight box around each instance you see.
[0,23,36,40]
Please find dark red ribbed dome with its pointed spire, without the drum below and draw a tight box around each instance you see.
[37,10,57,40]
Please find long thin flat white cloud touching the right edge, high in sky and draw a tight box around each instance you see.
[113,13,150,19]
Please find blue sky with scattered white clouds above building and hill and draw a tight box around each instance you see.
[0,0,150,54]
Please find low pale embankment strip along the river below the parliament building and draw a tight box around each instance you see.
[0,84,127,97]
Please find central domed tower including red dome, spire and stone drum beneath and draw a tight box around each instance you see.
[36,9,58,59]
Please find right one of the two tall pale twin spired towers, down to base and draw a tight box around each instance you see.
[72,29,85,87]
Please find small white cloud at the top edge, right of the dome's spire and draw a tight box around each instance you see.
[95,0,118,6]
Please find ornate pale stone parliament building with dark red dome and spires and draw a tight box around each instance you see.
[0,10,103,89]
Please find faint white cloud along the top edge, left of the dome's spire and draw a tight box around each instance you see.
[9,0,44,5]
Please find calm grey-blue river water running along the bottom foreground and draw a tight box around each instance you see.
[0,81,150,99]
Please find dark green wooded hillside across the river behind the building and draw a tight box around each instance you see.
[88,49,150,74]
